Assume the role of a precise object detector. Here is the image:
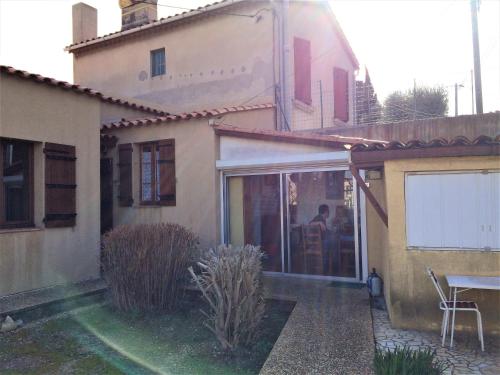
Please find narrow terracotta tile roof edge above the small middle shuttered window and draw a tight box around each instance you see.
[101,103,274,130]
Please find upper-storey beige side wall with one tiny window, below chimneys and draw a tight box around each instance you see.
[74,1,274,113]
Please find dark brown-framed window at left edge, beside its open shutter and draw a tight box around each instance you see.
[0,139,33,228]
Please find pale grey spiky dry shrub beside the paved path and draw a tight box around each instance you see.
[189,245,264,350]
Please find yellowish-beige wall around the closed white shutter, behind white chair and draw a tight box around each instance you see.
[384,156,500,334]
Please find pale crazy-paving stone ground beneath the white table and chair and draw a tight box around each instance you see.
[372,309,500,375]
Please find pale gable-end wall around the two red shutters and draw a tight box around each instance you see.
[288,1,355,130]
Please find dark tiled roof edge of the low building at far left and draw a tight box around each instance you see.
[0,65,169,116]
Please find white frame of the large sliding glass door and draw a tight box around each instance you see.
[220,165,368,282]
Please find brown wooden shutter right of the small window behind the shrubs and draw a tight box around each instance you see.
[157,139,175,206]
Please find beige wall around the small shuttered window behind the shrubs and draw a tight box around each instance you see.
[104,119,220,247]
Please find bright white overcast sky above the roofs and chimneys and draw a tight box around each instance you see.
[0,0,500,115]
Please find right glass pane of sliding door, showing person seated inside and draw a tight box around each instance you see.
[287,171,356,277]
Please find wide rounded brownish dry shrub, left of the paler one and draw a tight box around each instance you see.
[102,223,198,311]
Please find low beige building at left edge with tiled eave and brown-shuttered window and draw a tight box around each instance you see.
[0,66,164,296]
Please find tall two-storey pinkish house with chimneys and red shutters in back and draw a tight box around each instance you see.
[66,0,358,130]
